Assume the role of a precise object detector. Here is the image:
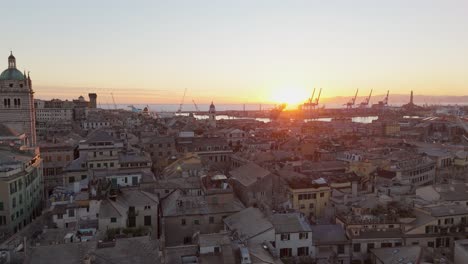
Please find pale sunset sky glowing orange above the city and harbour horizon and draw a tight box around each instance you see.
[0,0,468,104]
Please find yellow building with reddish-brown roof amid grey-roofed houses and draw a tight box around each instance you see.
[287,178,331,220]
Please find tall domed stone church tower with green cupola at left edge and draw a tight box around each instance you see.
[0,54,36,147]
